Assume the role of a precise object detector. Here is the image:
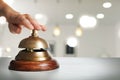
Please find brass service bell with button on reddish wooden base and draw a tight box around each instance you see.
[9,30,59,71]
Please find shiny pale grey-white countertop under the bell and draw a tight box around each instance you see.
[0,57,120,80]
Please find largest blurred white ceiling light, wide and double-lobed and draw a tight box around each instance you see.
[79,16,97,28]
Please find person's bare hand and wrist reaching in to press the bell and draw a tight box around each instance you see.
[0,0,46,34]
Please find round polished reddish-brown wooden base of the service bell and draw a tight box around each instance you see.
[9,59,59,71]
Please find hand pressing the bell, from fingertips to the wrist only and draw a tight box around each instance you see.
[6,12,46,34]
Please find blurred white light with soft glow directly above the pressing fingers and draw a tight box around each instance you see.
[35,14,48,25]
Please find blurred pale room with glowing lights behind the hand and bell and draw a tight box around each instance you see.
[0,0,120,57]
